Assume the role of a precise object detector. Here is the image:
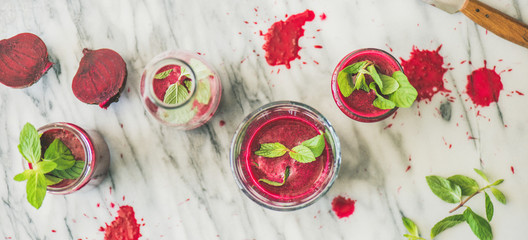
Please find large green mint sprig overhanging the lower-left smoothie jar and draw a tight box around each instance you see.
[13,123,84,209]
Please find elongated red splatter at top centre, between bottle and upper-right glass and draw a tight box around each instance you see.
[262,10,315,68]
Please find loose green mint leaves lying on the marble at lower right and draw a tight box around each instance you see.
[403,169,506,240]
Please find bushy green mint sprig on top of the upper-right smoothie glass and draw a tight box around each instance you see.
[337,60,418,109]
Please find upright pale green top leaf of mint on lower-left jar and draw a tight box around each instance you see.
[18,123,42,163]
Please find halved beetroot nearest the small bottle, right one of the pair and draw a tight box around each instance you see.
[72,48,127,109]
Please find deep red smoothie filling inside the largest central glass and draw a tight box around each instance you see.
[246,116,330,201]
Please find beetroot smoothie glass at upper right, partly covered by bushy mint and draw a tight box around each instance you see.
[332,48,403,122]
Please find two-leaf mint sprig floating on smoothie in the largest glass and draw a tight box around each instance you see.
[255,133,325,187]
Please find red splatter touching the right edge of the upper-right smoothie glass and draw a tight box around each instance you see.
[400,45,450,101]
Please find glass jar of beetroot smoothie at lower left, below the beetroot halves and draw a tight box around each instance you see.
[23,122,110,195]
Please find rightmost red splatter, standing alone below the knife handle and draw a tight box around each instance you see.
[466,61,502,107]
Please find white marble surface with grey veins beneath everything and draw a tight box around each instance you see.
[0,0,528,239]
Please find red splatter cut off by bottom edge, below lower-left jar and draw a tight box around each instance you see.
[99,206,141,240]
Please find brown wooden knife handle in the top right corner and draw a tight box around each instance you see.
[460,0,528,48]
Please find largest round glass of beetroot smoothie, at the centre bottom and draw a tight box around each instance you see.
[230,101,341,211]
